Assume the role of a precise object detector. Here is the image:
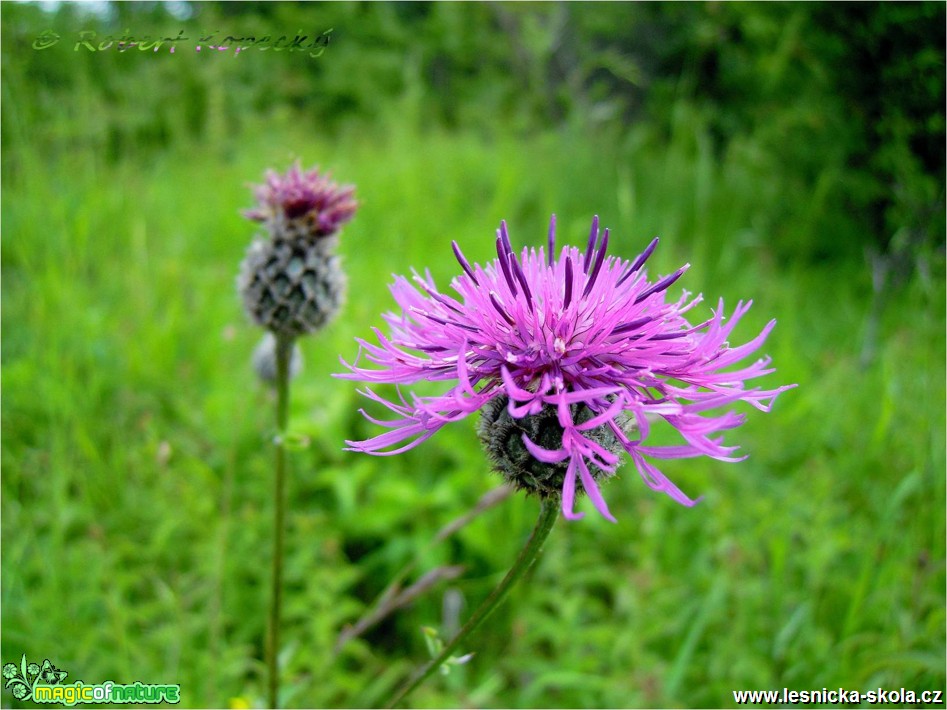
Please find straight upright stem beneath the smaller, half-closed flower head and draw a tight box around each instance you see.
[266,335,293,708]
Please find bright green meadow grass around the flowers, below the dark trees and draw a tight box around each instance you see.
[2,104,945,707]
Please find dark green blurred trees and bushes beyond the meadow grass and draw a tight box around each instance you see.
[2,2,945,261]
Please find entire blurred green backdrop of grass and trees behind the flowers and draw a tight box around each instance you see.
[0,2,945,707]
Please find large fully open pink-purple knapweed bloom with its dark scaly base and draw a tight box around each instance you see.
[340,215,793,521]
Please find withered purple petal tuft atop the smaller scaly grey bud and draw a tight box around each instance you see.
[244,161,358,237]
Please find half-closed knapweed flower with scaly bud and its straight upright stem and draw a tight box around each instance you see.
[237,161,358,708]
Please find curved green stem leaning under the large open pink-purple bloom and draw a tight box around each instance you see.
[385,499,559,708]
